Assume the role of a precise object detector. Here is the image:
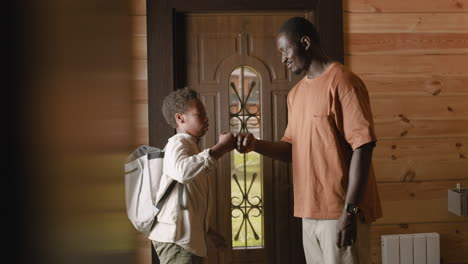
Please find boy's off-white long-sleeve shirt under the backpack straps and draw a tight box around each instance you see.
[149,133,216,257]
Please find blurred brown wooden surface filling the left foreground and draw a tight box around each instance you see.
[24,0,135,264]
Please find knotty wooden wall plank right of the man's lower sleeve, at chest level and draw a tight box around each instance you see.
[371,95,468,139]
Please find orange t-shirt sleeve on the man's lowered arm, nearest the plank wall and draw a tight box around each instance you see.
[339,74,377,150]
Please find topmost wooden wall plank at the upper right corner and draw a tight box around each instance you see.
[343,0,468,13]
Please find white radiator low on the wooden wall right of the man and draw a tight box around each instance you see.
[382,233,440,264]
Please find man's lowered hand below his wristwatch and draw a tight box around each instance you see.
[336,212,357,248]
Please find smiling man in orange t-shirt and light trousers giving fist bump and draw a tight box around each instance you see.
[237,17,382,264]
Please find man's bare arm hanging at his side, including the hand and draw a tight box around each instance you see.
[337,142,375,247]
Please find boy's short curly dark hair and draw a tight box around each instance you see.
[161,87,198,128]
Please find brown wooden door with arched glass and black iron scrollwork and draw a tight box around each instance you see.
[175,12,311,263]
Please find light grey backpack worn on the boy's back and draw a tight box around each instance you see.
[125,145,183,236]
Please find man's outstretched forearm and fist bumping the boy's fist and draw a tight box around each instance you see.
[237,133,292,162]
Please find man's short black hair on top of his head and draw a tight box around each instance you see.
[278,17,320,45]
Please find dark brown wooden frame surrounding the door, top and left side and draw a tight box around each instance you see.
[146,0,344,147]
